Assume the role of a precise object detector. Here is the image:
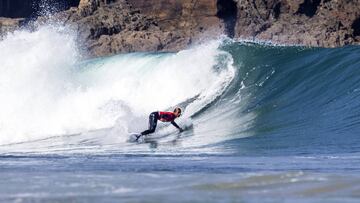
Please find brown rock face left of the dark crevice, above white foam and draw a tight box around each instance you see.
[37,0,223,56]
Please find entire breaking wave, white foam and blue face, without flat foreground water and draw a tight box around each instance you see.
[0,27,360,154]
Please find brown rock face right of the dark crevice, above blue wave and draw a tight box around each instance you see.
[235,0,360,47]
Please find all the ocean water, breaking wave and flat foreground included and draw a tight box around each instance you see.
[0,26,360,202]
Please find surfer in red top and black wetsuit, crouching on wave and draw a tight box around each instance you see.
[136,107,183,140]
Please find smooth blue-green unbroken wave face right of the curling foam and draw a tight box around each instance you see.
[214,43,360,153]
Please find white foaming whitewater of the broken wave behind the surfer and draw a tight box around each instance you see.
[0,26,234,144]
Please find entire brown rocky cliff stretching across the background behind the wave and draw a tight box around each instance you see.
[0,0,360,56]
